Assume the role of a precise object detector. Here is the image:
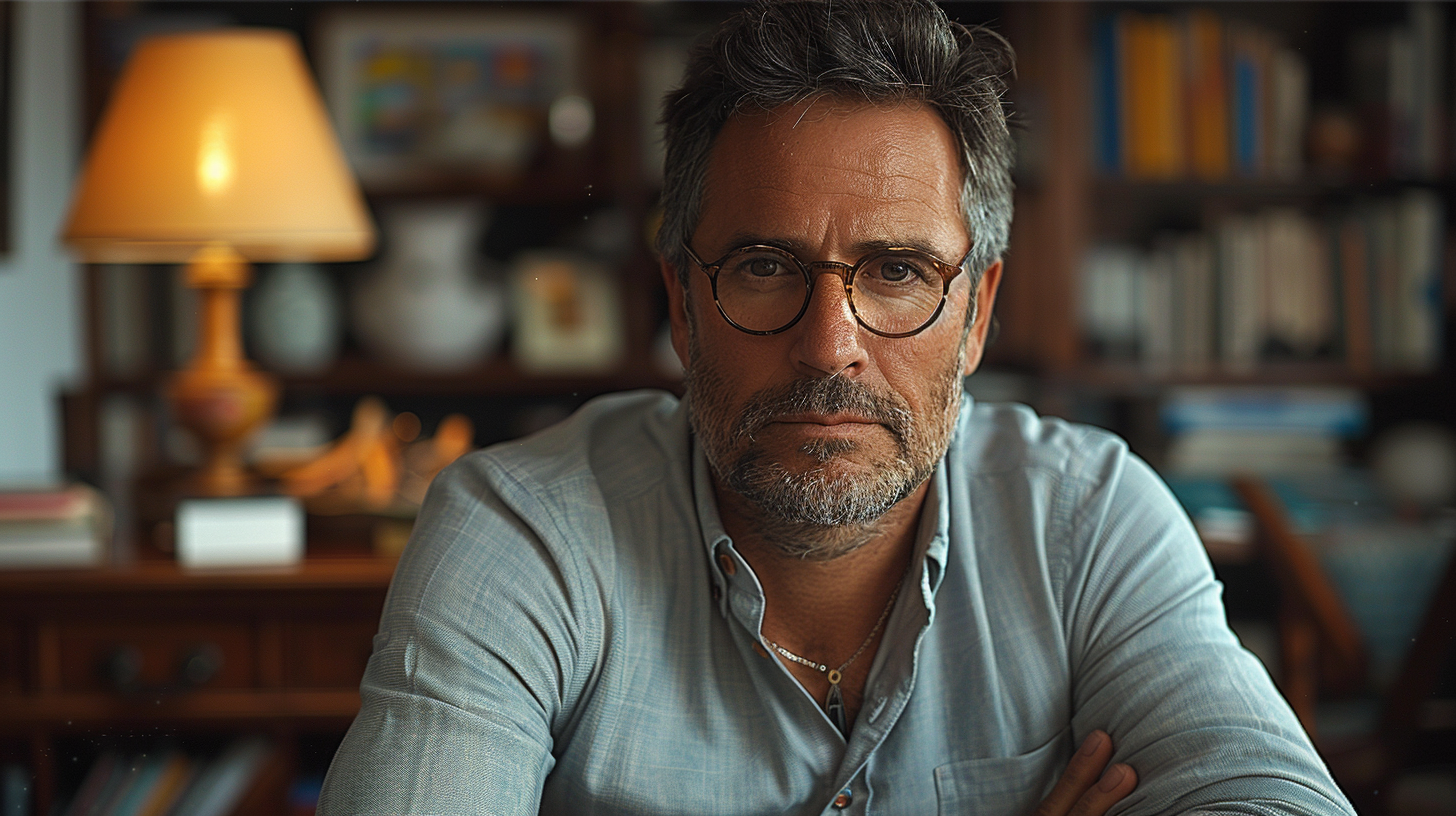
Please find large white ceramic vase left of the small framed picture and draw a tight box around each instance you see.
[352,201,505,372]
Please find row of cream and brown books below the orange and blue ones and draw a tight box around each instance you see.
[1082,189,1444,374]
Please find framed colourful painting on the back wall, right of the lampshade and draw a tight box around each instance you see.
[316,9,581,188]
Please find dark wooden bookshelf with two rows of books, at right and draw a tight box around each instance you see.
[989,3,1456,428]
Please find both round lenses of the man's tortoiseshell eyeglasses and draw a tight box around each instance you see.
[716,248,945,334]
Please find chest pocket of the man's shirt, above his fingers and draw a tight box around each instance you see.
[935,729,1072,816]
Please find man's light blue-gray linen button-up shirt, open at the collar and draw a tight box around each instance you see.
[319,392,1353,816]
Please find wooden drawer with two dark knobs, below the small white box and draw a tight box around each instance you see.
[55,621,258,694]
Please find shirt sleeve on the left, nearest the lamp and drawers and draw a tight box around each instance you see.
[319,455,601,816]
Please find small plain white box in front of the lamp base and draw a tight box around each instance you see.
[178,495,303,567]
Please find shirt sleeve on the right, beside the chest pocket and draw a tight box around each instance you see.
[1061,450,1354,816]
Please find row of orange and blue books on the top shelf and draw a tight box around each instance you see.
[1092,9,1309,181]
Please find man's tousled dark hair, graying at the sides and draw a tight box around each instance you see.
[657,0,1016,295]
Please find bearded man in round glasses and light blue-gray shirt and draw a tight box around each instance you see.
[320,0,1351,816]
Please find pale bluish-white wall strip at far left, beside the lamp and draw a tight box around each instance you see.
[0,1,83,485]
